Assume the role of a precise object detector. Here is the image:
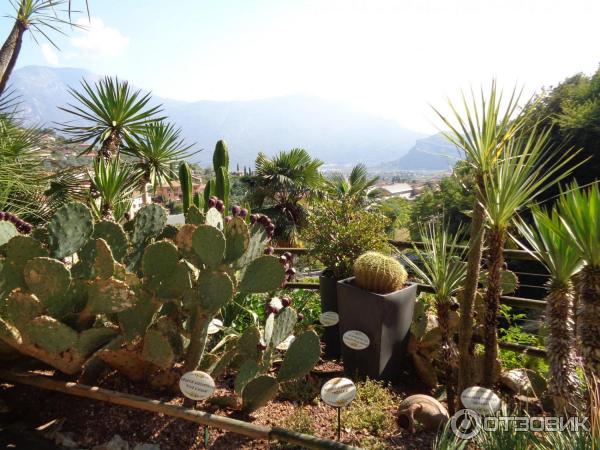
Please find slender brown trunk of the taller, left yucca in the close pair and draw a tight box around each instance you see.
[458,195,485,400]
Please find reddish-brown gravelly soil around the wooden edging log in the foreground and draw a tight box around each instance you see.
[0,361,435,450]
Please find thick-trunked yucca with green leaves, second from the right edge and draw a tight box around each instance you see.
[516,207,581,411]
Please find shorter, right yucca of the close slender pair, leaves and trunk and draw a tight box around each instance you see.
[481,129,577,386]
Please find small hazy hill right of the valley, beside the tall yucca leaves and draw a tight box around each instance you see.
[382,134,461,170]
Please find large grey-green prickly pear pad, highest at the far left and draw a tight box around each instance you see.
[48,202,94,259]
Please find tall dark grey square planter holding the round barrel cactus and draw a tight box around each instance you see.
[337,277,417,382]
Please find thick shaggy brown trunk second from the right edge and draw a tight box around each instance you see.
[546,283,577,412]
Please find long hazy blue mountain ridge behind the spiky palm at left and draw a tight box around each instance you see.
[11,66,432,166]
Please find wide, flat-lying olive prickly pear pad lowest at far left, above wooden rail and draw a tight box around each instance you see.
[21,316,78,354]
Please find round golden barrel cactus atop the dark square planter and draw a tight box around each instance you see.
[354,252,408,294]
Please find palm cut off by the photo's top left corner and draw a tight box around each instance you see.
[0,0,89,95]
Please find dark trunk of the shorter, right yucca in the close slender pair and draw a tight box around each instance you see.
[483,228,506,387]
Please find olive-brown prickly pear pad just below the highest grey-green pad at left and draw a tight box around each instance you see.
[23,257,71,316]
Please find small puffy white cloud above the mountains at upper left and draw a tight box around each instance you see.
[71,17,129,57]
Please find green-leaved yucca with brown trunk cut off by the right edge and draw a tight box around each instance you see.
[558,183,600,379]
